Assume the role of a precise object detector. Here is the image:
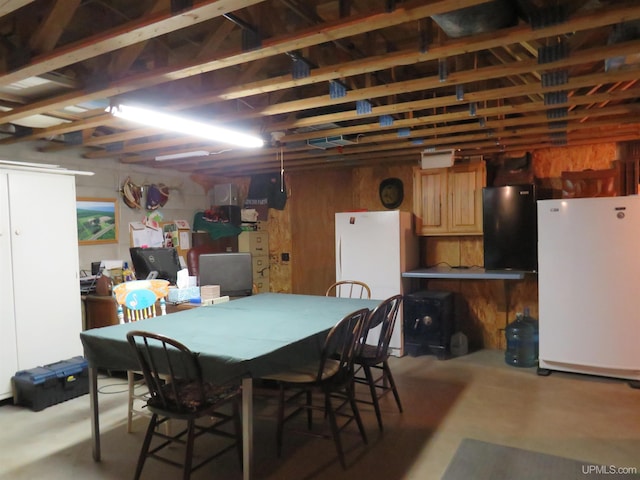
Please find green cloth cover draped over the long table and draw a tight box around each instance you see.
[80,293,380,381]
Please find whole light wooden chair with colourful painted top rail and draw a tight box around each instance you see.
[113,280,169,433]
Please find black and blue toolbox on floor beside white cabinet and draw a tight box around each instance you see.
[11,357,89,412]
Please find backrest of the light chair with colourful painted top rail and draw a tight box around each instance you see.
[113,280,169,323]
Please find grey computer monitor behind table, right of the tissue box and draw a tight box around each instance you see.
[198,253,253,297]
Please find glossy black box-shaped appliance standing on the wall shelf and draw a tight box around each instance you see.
[482,184,538,271]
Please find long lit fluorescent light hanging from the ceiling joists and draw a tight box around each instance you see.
[106,105,264,148]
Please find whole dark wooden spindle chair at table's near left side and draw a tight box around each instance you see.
[127,331,242,480]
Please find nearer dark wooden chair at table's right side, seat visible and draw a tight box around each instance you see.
[265,308,369,468]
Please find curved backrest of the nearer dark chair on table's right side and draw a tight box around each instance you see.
[316,308,369,382]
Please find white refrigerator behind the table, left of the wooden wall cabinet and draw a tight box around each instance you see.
[335,210,419,356]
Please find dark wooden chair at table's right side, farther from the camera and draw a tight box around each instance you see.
[354,295,402,431]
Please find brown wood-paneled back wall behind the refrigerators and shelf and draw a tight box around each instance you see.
[268,144,617,349]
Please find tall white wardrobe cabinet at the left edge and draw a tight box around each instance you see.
[0,166,82,399]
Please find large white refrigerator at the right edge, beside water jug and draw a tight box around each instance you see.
[538,196,640,381]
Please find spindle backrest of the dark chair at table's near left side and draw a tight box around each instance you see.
[127,330,206,414]
